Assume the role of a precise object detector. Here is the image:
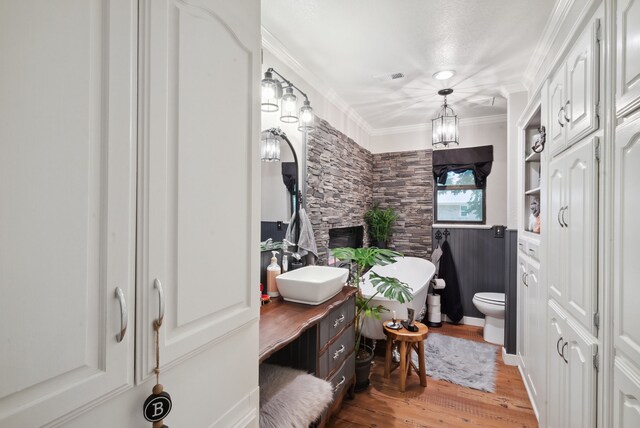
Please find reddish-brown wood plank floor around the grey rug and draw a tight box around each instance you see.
[327,323,538,428]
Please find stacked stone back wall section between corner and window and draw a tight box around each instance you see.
[373,150,433,258]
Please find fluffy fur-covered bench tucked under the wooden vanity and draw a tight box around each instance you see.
[260,364,333,428]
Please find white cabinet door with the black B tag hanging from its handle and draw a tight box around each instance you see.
[137,0,260,380]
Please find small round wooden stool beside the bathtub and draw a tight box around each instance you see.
[383,321,429,392]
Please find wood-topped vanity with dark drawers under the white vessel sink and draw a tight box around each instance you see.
[260,286,357,424]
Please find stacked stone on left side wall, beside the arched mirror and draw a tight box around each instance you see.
[306,120,372,265]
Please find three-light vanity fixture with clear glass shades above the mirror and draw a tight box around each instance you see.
[260,67,315,132]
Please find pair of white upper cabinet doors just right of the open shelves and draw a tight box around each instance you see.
[547,15,600,154]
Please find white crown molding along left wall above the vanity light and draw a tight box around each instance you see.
[261,25,373,136]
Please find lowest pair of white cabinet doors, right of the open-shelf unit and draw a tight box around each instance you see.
[546,300,600,428]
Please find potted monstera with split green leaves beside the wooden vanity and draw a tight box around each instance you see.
[331,247,413,390]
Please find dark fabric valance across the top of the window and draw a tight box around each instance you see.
[433,146,493,188]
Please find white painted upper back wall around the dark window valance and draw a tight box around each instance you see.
[370,118,508,225]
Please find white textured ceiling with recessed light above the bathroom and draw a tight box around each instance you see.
[262,0,554,129]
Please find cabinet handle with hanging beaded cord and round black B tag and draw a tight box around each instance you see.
[142,279,173,428]
